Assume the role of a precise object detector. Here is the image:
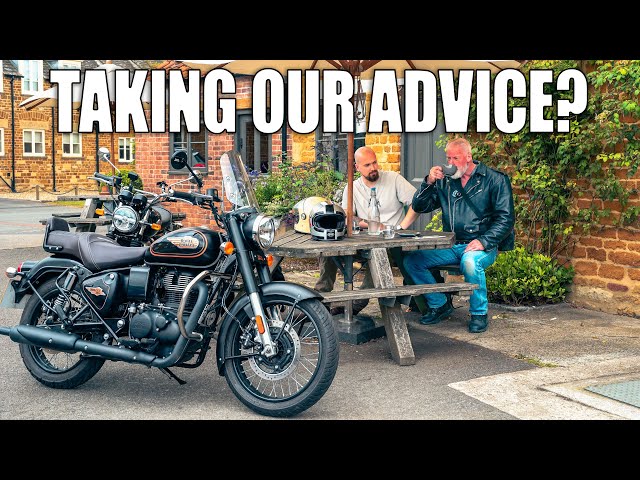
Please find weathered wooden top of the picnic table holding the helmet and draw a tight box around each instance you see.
[268,230,455,258]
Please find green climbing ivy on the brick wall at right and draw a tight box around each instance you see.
[464,60,640,264]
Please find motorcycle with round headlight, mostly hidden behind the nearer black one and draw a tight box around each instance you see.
[94,147,186,247]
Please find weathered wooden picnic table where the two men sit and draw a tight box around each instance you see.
[269,230,478,365]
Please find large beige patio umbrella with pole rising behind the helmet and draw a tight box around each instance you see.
[181,60,523,236]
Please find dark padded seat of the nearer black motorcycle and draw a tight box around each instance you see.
[46,220,148,272]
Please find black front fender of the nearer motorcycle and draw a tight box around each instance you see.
[216,282,322,376]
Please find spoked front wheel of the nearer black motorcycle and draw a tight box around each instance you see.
[218,297,339,417]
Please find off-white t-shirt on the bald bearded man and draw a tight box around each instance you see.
[342,170,416,225]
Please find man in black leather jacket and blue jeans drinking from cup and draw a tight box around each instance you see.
[404,138,515,333]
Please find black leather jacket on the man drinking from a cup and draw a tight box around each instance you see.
[412,160,515,250]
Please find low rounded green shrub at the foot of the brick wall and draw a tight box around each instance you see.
[486,247,574,305]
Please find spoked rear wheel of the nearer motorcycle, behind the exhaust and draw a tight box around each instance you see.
[20,279,105,389]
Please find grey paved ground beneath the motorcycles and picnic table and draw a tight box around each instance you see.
[0,199,640,420]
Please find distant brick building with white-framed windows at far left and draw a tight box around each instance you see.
[0,60,158,192]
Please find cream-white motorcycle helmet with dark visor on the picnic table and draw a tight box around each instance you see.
[293,197,347,241]
